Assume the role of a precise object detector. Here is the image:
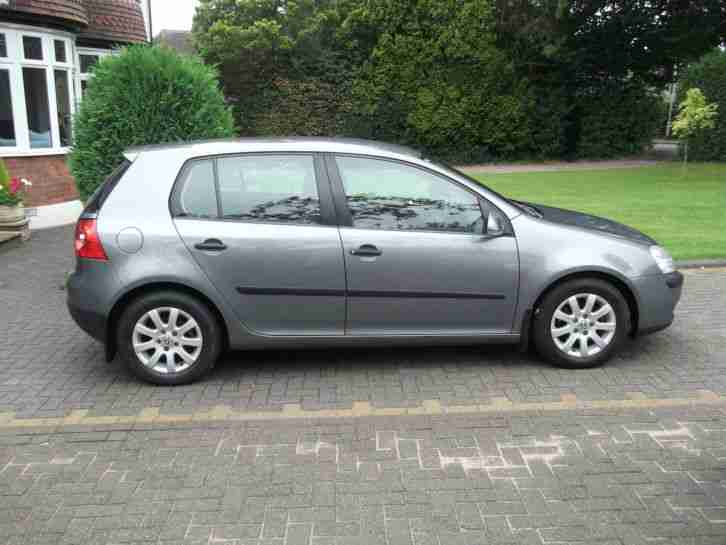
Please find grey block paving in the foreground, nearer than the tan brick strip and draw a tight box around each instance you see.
[0,408,726,545]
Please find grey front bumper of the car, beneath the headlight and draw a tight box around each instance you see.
[633,271,684,335]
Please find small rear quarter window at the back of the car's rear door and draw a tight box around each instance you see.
[172,159,219,218]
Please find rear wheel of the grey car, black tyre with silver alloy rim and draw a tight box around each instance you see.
[117,291,222,386]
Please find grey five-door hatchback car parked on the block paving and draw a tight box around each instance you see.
[68,138,683,385]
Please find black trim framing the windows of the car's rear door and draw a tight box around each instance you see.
[169,150,338,227]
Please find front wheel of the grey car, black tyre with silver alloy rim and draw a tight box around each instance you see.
[532,278,631,369]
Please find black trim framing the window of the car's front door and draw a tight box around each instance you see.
[325,152,513,237]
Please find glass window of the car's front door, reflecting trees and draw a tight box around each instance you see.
[336,157,483,233]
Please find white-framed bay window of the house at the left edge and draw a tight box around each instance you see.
[0,25,76,156]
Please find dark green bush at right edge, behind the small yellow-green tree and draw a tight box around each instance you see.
[679,49,726,161]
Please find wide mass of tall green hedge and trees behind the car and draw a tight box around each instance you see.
[194,0,723,162]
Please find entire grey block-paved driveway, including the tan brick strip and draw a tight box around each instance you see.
[0,228,726,545]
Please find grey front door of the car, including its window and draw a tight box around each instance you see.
[328,155,519,335]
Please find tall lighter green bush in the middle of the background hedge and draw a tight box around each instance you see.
[342,0,532,162]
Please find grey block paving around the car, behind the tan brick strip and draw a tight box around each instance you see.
[0,228,726,417]
